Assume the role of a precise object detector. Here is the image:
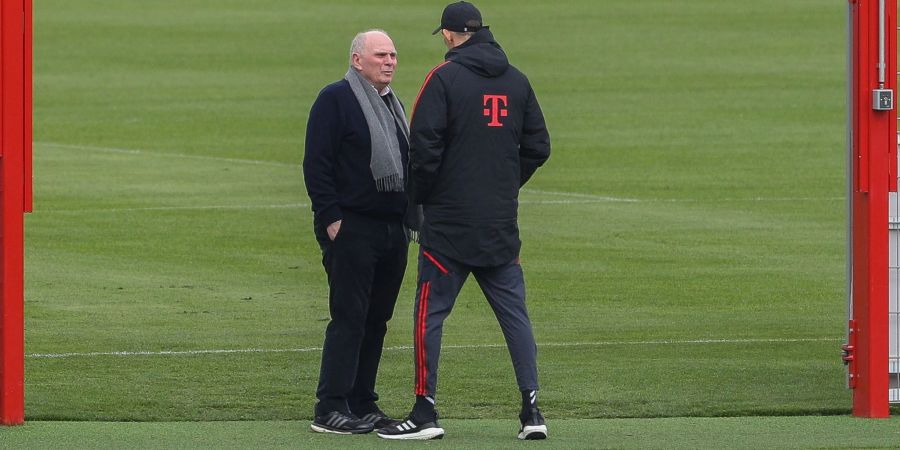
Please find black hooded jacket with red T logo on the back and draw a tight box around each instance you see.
[409,29,550,267]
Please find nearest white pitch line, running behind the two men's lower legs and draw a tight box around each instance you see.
[25,338,843,359]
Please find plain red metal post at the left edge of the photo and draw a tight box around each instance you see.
[0,0,31,425]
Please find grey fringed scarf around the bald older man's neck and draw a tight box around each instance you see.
[344,66,409,192]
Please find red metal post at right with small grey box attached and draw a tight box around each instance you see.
[848,0,897,417]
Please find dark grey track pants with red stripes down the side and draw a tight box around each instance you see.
[413,247,538,396]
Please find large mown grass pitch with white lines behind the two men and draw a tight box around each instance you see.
[15,0,895,447]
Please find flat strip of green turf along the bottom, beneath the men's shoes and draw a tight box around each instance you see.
[0,417,900,449]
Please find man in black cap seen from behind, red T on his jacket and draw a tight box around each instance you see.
[378,2,550,439]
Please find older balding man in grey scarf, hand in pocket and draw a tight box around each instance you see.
[303,30,409,434]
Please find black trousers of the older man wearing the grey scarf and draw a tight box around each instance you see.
[315,212,409,415]
